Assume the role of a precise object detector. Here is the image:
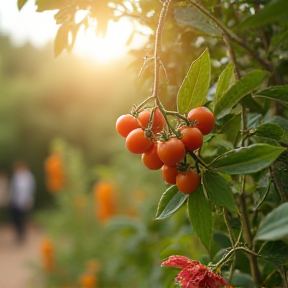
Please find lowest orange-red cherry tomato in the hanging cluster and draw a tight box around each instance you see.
[176,169,200,194]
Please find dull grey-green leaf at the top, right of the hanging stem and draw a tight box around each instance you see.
[174,6,222,37]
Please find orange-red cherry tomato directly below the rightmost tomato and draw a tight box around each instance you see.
[181,127,203,151]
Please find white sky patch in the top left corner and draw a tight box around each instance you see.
[0,0,58,47]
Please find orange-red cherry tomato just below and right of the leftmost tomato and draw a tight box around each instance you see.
[126,128,153,154]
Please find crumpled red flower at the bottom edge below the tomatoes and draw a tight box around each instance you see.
[161,255,232,288]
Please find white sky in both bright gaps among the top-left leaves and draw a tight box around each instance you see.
[0,0,150,61]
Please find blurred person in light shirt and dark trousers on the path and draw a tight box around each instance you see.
[9,160,36,242]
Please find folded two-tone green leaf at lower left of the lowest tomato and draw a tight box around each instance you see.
[156,185,188,220]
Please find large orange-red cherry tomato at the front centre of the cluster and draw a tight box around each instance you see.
[157,138,186,166]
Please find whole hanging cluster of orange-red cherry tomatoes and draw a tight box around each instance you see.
[116,107,215,194]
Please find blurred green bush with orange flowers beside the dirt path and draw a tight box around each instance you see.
[34,139,205,288]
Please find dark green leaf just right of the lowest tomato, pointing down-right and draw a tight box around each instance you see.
[203,171,237,211]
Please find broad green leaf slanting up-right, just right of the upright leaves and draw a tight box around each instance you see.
[214,70,269,117]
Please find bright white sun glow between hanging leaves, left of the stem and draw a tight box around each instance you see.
[73,19,134,62]
